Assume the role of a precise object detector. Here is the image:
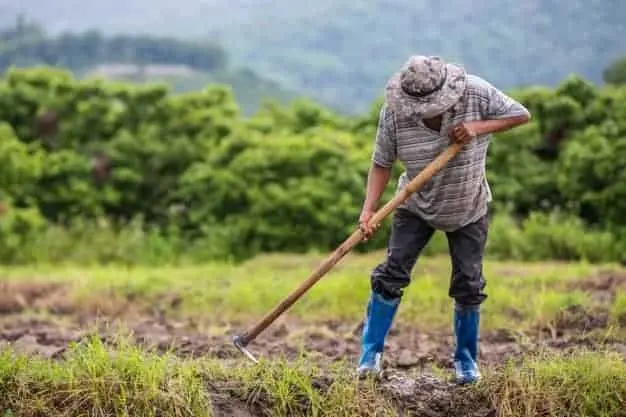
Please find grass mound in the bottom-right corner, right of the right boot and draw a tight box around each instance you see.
[477,351,626,417]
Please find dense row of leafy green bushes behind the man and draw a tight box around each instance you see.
[0,68,626,262]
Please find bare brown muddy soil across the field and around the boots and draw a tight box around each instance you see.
[0,307,626,417]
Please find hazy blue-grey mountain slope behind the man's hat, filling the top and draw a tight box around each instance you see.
[0,0,626,111]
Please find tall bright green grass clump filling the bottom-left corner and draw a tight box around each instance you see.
[0,336,210,417]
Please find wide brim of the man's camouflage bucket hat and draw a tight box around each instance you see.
[385,64,466,118]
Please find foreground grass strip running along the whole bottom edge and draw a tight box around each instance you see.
[0,337,626,417]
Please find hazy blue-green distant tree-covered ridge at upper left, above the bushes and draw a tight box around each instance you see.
[0,18,294,114]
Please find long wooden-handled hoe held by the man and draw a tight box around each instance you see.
[233,143,463,363]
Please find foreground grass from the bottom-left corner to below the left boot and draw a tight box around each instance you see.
[0,337,393,417]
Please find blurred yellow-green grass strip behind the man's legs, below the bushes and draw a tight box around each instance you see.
[0,252,624,329]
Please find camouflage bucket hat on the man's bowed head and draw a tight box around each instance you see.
[385,55,466,118]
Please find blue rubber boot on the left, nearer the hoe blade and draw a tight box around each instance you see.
[357,292,400,377]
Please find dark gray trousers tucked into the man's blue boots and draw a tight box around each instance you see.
[371,208,489,306]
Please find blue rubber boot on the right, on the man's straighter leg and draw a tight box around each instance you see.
[454,306,480,384]
